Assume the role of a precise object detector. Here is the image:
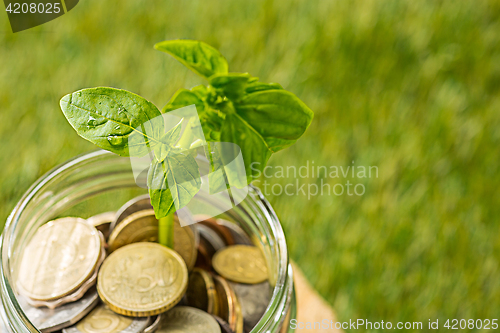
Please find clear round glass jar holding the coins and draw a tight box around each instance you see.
[0,151,296,333]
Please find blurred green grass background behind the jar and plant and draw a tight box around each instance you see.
[0,0,500,325]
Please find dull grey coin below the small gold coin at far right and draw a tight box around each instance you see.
[229,282,271,332]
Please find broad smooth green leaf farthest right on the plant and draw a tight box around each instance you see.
[234,89,313,152]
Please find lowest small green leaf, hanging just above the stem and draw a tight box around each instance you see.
[148,151,201,218]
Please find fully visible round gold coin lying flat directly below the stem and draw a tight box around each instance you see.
[97,242,188,317]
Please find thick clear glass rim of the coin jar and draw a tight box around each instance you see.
[0,150,293,333]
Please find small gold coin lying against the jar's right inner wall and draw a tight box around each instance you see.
[212,245,268,284]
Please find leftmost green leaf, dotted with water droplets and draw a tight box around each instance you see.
[60,87,163,156]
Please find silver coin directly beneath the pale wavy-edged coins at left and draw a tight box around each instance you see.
[18,287,99,333]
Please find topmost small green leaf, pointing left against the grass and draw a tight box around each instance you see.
[155,39,228,79]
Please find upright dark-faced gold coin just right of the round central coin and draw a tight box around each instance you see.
[186,268,218,314]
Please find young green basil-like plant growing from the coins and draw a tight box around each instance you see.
[60,40,313,247]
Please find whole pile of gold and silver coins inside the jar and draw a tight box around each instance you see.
[17,196,271,333]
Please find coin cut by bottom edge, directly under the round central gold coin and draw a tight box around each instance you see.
[62,304,151,333]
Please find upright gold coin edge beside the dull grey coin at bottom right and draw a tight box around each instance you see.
[214,276,243,333]
